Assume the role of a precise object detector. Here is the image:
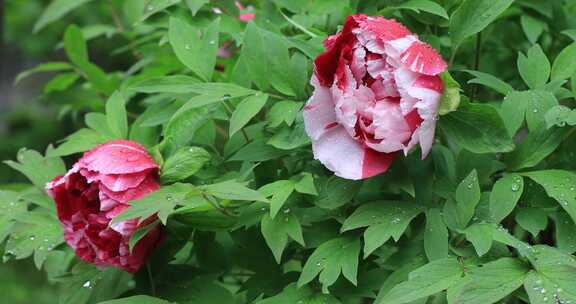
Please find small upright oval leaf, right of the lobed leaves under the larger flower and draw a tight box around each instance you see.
[424,208,448,261]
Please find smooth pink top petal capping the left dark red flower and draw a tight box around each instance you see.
[78,140,158,174]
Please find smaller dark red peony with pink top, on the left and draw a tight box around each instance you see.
[46,140,163,272]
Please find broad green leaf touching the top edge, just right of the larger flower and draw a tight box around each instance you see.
[450,0,513,45]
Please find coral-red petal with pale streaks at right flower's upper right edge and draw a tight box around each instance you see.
[401,42,448,75]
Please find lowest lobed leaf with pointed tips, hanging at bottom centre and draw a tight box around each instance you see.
[298,236,360,293]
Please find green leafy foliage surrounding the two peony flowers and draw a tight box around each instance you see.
[0,0,576,304]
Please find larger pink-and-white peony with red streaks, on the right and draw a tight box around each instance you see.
[304,14,447,179]
